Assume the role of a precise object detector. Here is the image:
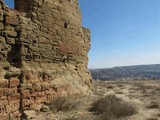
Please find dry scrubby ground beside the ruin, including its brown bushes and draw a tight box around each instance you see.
[36,80,160,120]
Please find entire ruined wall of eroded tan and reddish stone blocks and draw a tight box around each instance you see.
[0,0,92,119]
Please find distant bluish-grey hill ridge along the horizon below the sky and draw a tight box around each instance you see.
[90,64,160,80]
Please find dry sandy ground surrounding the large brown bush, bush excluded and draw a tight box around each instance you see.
[25,80,160,120]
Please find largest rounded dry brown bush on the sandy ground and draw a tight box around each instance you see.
[91,95,136,120]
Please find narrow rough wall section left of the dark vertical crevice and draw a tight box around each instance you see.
[0,1,20,120]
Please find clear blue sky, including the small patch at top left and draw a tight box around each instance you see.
[5,0,160,68]
